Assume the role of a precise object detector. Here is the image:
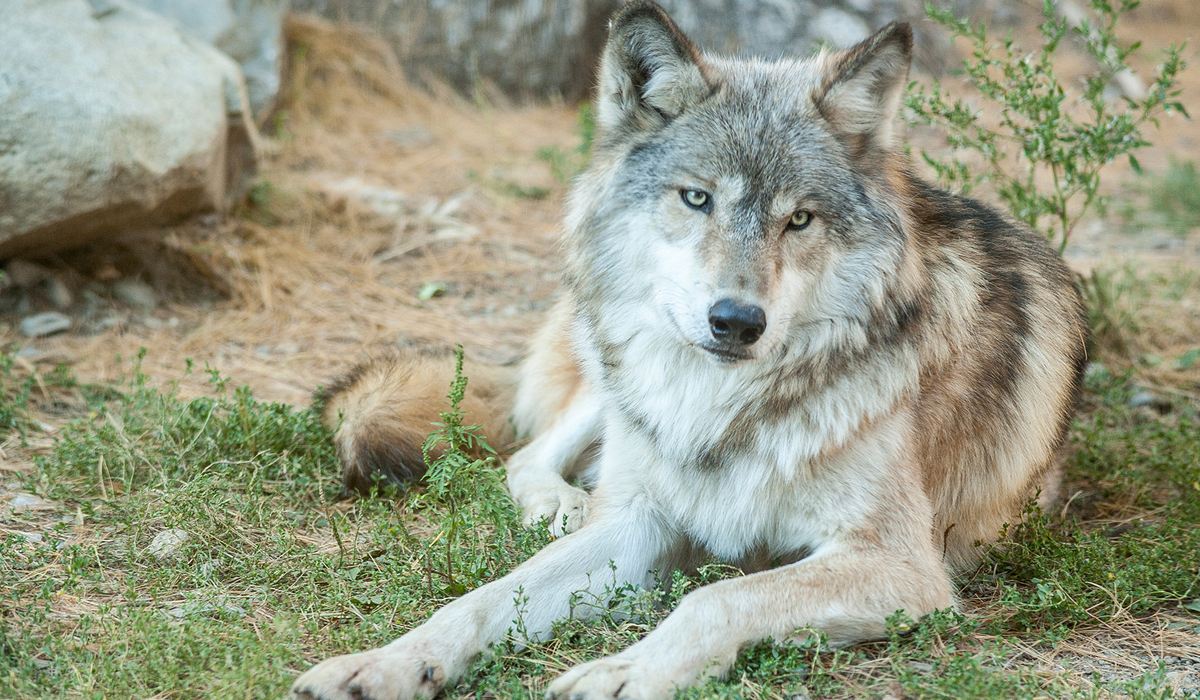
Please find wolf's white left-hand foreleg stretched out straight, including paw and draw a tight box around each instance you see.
[292,495,674,700]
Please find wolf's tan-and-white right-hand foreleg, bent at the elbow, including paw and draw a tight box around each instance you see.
[546,532,954,700]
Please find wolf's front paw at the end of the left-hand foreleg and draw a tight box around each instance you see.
[290,648,446,700]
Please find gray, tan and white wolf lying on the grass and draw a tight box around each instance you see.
[293,1,1087,700]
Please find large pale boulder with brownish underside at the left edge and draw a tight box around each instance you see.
[0,0,257,258]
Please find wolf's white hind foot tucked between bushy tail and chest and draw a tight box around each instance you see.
[505,390,601,537]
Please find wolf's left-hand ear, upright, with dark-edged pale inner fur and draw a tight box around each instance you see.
[596,1,709,136]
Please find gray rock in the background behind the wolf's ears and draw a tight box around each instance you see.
[292,0,941,100]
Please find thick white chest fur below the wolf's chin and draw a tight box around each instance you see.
[590,328,913,561]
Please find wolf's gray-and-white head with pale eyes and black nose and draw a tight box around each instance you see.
[568,2,912,363]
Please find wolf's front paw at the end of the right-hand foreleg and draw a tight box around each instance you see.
[546,656,676,700]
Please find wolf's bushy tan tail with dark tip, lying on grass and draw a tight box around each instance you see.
[318,352,512,491]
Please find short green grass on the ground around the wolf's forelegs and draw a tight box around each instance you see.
[0,350,1200,698]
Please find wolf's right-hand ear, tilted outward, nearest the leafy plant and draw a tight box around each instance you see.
[814,22,912,154]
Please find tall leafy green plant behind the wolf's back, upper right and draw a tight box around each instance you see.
[907,0,1187,251]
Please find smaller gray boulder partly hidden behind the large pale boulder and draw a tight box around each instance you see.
[132,0,289,124]
